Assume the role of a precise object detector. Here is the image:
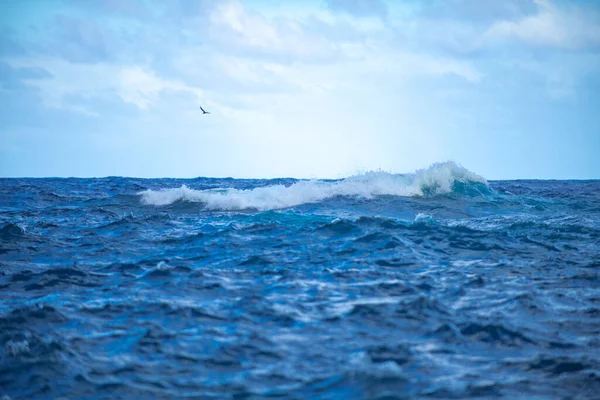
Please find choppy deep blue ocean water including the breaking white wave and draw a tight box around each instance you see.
[0,164,600,399]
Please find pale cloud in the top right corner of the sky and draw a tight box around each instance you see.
[398,0,600,57]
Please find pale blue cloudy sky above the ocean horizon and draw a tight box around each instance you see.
[0,0,600,179]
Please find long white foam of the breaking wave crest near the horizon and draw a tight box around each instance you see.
[138,162,487,210]
